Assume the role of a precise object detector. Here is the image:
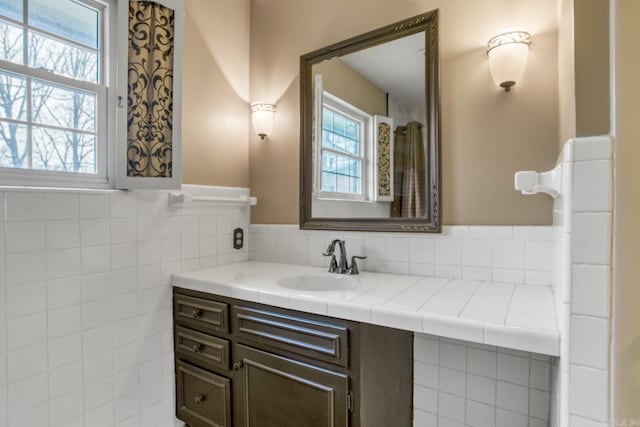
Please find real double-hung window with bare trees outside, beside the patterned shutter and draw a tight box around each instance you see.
[0,0,113,186]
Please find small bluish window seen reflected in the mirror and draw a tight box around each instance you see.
[319,92,371,200]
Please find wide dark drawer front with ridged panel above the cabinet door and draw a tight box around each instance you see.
[232,306,349,367]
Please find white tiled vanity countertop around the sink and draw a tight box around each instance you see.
[172,261,560,356]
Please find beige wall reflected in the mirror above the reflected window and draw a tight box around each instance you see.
[312,58,387,115]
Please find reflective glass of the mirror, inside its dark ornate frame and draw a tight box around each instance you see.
[311,32,428,218]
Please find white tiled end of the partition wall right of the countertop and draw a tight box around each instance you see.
[551,137,612,427]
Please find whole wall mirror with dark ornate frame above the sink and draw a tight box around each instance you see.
[300,10,440,232]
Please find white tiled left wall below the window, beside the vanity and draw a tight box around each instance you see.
[0,186,249,427]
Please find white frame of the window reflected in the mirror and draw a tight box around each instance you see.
[316,91,373,201]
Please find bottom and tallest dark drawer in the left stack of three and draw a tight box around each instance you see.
[176,362,231,427]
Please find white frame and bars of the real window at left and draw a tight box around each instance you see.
[0,0,118,189]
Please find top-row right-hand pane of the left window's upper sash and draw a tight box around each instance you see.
[28,0,98,48]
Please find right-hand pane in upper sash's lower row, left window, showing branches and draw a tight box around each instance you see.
[29,32,98,82]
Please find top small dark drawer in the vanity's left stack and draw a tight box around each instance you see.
[174,294,229,333]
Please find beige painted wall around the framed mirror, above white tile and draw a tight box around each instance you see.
[249,0,559,225]
